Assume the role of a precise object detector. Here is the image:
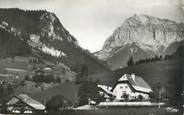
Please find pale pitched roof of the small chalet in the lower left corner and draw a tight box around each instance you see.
[6,94,45,110]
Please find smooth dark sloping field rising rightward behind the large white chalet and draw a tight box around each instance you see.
[89,58,183,88]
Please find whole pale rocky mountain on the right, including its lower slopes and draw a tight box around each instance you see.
[95,15,184,68]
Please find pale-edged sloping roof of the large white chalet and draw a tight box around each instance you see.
[118,74,152,93]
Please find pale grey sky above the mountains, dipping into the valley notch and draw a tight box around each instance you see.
[0,0,184,52]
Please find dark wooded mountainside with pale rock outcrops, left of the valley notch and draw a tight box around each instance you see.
[0,9,108,73]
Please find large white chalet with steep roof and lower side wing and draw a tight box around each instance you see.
[98,74,152,101]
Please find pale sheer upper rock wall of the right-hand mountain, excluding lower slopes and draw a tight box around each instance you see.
[100,14,184,51]
